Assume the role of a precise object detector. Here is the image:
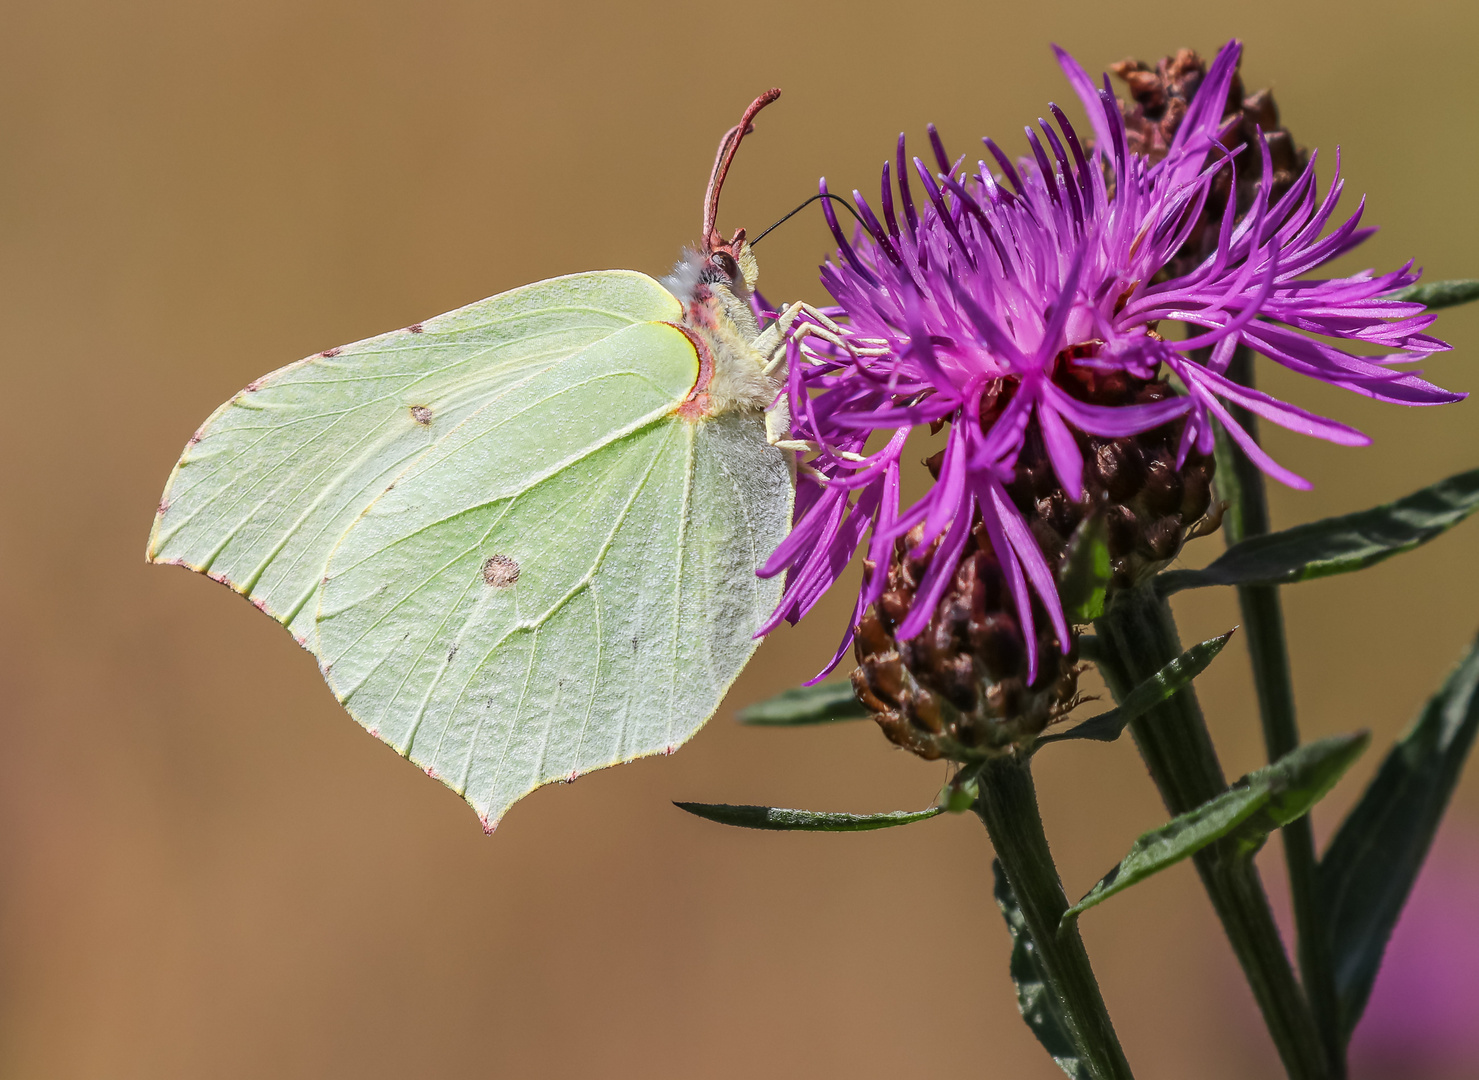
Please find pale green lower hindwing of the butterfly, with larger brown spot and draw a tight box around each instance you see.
[318,323,791,828]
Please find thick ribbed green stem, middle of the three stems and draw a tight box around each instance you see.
[1096,586,1328,1080]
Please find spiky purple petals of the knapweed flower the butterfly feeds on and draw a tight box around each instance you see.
[762,41,1463,682]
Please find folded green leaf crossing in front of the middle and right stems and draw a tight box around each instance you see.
[1059,731,1371,928]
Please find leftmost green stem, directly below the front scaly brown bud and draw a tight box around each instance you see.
[975,757,1133,1080]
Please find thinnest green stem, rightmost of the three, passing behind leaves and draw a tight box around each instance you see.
[1216,348,1346,1080]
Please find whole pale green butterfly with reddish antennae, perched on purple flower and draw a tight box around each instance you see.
[146,90,851,831]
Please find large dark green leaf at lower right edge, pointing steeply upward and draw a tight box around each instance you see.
[1319,630,1479,1039]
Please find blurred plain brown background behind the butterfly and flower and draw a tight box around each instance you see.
[0,0,1479,1080]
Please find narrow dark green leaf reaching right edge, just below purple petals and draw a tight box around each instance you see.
[1157,469,1479,596]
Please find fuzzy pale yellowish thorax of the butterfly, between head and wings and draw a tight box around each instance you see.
[663,240,781,420]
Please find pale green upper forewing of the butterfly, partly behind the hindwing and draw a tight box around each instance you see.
[148,271,680,648]
